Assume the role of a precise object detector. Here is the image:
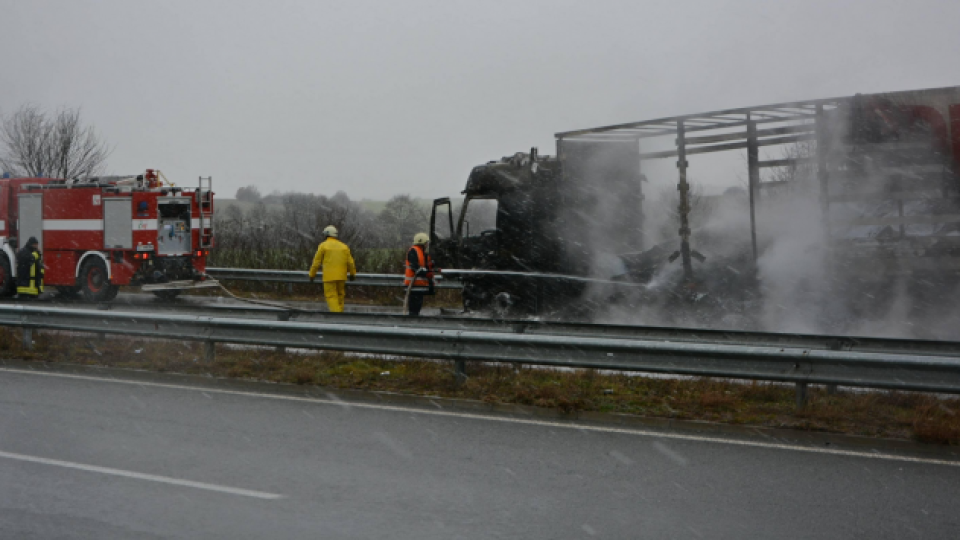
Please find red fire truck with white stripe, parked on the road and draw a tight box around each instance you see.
[0,169,218,302]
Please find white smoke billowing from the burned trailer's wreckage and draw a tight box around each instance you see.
[587,139,960,339]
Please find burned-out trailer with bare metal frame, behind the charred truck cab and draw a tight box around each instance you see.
[557,87,960,326]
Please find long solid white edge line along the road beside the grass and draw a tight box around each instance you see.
[0,368,960,467]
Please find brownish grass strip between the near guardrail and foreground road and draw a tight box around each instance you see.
[0,328,960,445]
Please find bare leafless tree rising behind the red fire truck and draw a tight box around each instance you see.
[0,105,110,178]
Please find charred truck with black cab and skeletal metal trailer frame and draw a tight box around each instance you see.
[431,87,960,313]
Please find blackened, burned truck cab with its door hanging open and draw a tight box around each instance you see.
[430,144,640,315]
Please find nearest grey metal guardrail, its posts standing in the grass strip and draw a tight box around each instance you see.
[0,306,960,406]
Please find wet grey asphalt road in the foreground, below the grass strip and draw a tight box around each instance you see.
[0,368,960,540]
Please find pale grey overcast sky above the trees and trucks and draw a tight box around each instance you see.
[0,0,960,199]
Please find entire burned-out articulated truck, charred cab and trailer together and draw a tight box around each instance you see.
[431,87,960,320]
